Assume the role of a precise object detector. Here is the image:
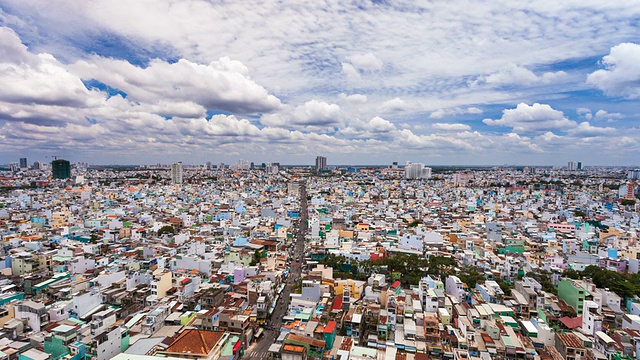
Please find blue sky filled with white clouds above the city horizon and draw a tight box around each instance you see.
[0,0,640,166]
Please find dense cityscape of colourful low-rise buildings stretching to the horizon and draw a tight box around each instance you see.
[0,160,640,360]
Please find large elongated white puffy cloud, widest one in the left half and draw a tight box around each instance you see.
[71,57,282,113]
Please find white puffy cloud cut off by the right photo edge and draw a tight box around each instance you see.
[587,43,640,99]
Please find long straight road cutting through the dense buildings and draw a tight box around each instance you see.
[244,181,308,359]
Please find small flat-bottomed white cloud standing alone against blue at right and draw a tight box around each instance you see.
[482,103,578,134]
